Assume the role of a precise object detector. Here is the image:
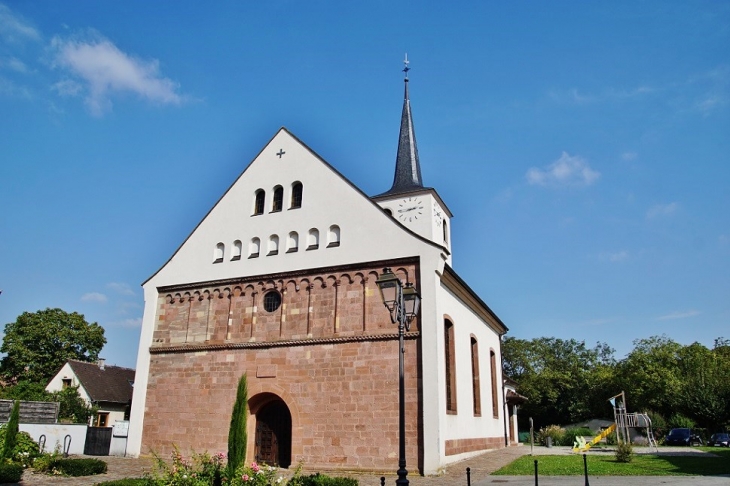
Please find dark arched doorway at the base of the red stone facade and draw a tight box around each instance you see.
[254,398,291,468]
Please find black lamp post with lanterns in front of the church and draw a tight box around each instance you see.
[375,268,421,486]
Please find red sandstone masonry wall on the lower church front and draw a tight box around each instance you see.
[142,264,422,471]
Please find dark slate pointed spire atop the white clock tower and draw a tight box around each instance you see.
[386,54,423,194]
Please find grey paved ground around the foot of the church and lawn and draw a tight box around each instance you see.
[12,446,730,486]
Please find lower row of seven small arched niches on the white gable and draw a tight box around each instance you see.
[213,224,340,263]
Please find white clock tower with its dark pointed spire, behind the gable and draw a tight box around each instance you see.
[373,54,452,262]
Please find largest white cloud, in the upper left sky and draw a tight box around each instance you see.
[51,36,183,116]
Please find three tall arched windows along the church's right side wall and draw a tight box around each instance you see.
[444,319,499,418]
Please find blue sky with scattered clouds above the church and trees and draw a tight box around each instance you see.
[0,0,730,367]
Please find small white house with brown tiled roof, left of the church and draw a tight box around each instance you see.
[46,359,134,427]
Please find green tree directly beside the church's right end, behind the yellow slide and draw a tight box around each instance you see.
[502,337,615,428]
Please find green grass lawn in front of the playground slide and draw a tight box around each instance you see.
[493,447,730,476]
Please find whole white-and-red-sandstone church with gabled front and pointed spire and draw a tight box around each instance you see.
[127,64,517,474]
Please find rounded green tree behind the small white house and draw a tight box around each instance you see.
[0,309,106,383]
